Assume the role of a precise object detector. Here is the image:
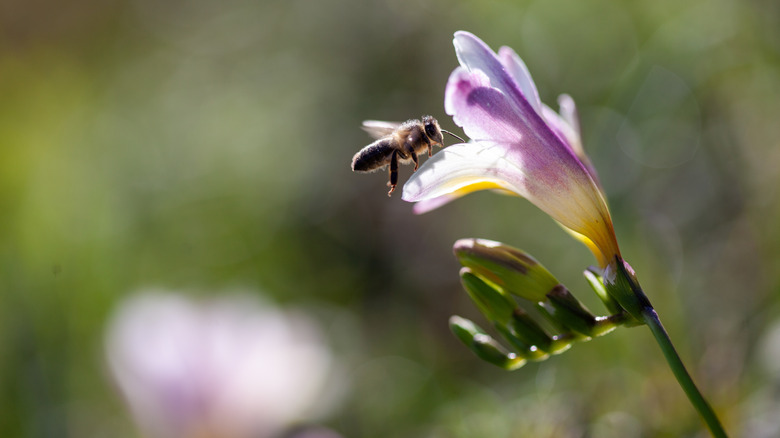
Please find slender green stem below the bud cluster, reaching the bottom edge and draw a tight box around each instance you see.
[642,306,727,438]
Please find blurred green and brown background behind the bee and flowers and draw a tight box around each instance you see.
[0,0,780,438]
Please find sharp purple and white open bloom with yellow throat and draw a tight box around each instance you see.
[403,32,620,267]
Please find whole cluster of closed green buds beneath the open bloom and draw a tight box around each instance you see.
[450,239,643,370]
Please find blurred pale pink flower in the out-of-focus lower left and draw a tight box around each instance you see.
[106,292,332,438]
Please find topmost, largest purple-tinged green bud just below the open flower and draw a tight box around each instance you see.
[453,239,558,303]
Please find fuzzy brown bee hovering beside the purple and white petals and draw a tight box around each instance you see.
[352,116,463,196]
